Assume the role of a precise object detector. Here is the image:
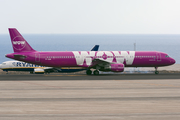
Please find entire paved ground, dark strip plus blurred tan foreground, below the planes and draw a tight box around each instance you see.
[0,74,180,120]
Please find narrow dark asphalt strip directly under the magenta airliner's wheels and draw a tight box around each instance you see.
[0,73,180,81]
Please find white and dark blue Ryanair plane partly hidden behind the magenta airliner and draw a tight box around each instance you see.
[0,45,99,74]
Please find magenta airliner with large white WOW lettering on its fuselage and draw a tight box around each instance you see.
[6,28,175,75]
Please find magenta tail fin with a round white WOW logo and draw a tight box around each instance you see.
[9,28,35,52]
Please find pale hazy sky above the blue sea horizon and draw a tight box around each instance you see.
[0,0,180,34]
